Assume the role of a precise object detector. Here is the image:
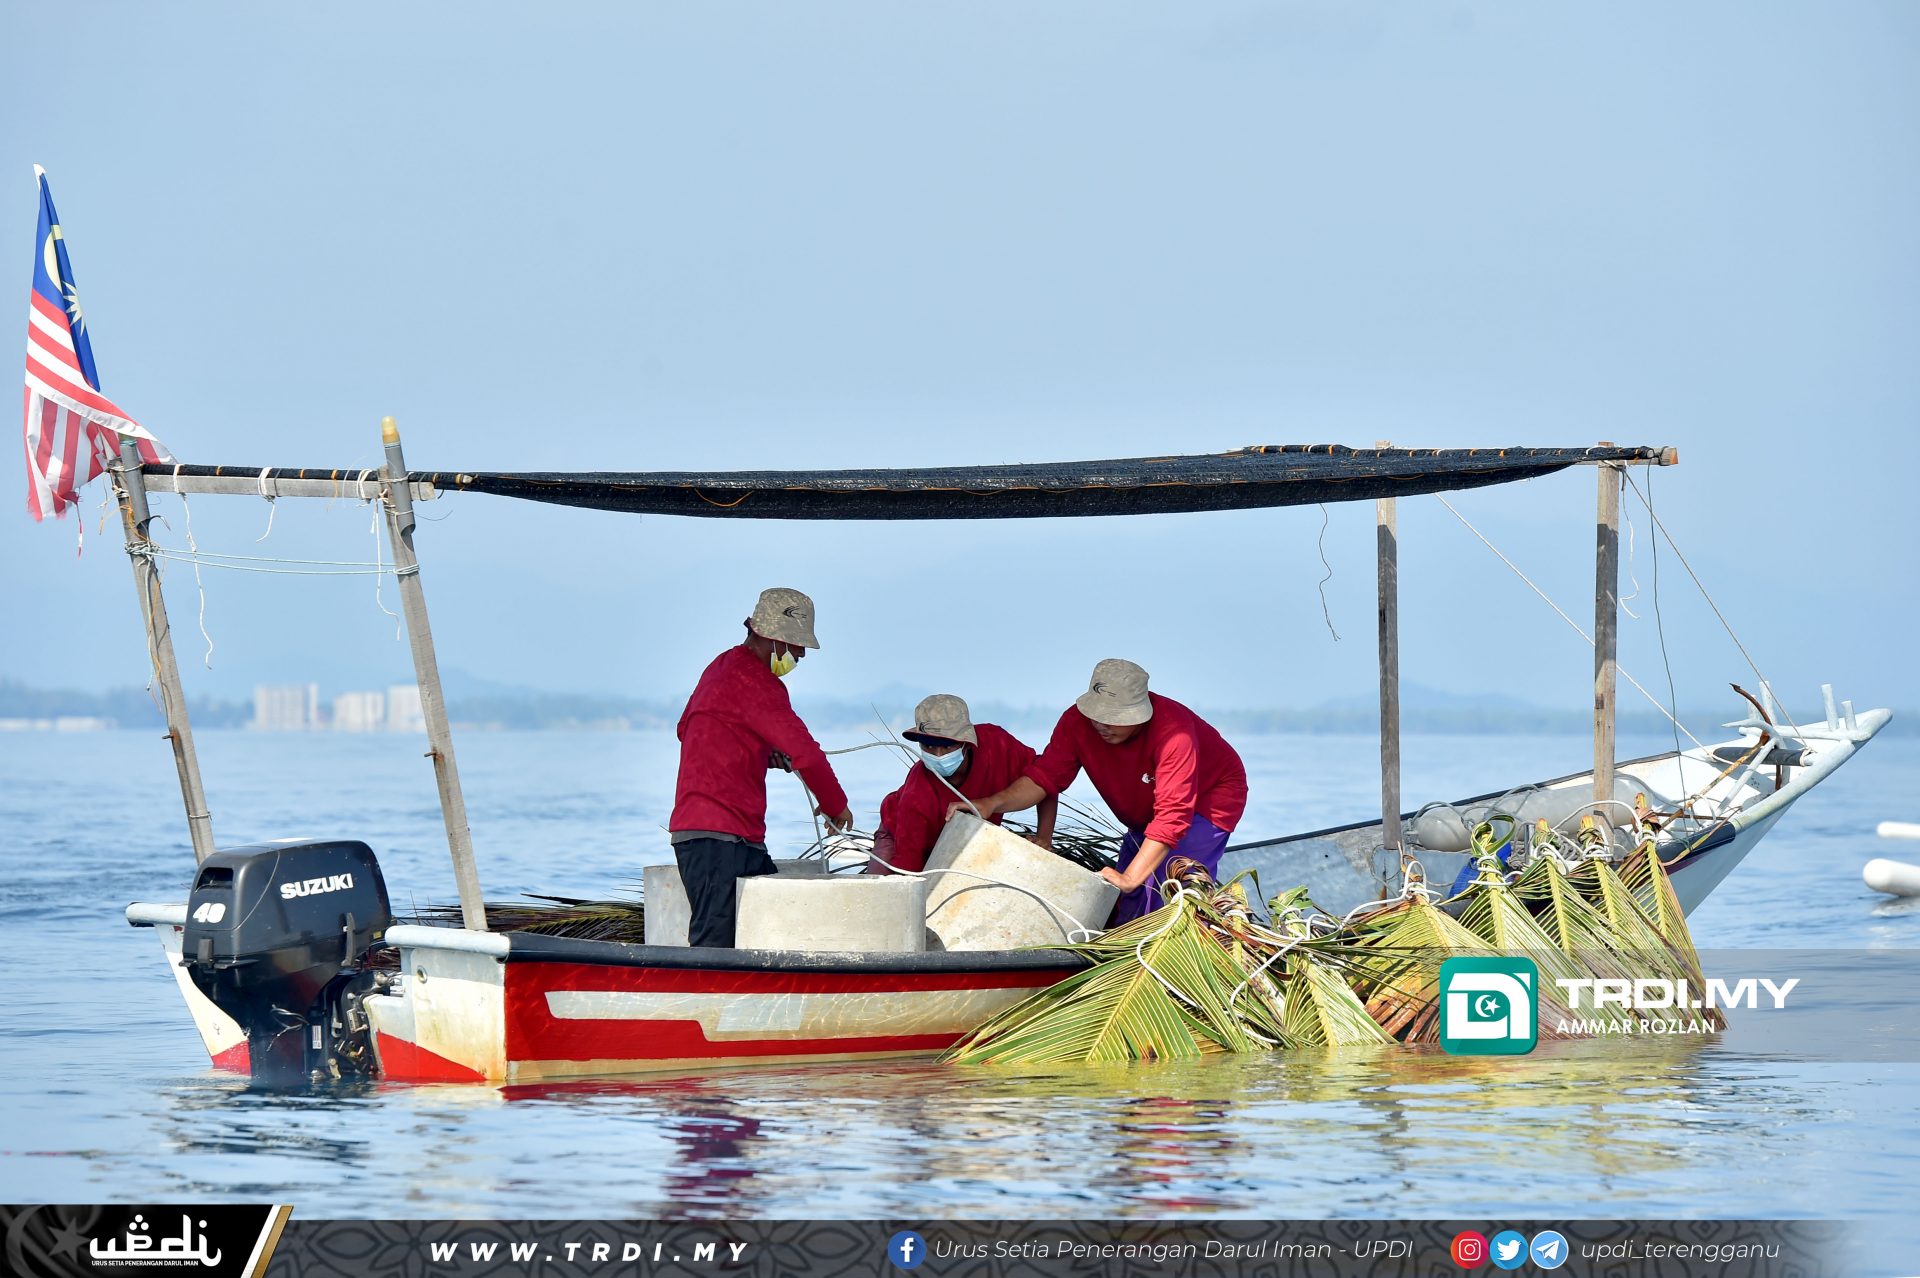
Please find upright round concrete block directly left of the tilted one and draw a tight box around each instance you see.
[735,875,927,954]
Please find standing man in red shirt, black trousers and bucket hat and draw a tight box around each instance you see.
[666,589,852,948]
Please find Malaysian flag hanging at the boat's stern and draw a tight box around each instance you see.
[27,165,173,520]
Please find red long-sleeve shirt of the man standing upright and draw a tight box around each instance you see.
[666,645,847,842]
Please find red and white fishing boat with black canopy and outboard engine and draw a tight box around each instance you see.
[113,435,1889,1082]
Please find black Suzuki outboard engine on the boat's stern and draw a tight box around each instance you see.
[180,839,394,1080]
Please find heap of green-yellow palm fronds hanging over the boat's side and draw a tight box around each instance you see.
[948,809,1713,1065]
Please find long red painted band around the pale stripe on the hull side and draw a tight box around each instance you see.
[505,963,1073,1061]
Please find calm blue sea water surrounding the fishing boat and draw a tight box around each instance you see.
[0,725,1920,1224]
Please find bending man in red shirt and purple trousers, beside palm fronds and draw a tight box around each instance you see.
[954,658,1246,925]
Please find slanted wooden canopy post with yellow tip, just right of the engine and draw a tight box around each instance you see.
[380,416,486,933]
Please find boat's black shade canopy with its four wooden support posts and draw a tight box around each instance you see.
[111,433,1680,933]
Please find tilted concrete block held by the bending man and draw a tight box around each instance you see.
[927,812,1119,950]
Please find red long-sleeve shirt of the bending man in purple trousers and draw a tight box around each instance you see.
[1025,693,1246,846]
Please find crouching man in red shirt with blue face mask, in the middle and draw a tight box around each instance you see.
[866,693,1060,873]
